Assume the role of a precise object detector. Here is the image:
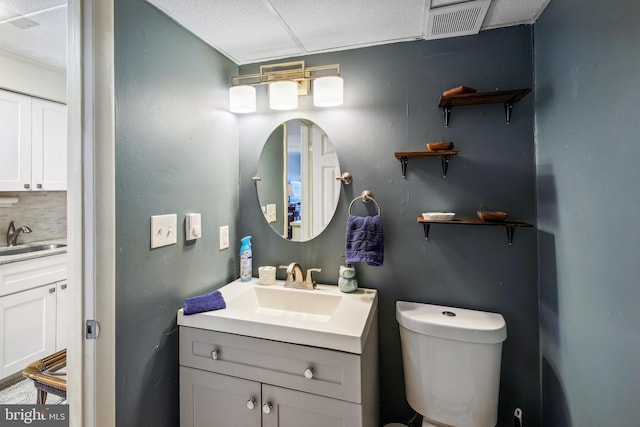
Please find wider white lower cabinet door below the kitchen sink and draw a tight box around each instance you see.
[0,284,56,378]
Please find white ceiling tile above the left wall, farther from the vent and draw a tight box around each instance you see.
[148,0,302,64]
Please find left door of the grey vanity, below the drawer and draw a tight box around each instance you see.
[180,366,260,427]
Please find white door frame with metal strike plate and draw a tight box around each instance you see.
[67,0,115,427]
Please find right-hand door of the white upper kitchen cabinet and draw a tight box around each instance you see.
[31,99,67,191]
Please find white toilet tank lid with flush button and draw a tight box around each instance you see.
[396,301,507,344]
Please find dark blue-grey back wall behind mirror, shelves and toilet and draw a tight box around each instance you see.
[239,26,540,426]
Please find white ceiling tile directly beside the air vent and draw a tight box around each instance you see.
[269,0,427,52]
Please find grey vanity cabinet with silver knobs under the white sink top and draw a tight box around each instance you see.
[180,319,379,427]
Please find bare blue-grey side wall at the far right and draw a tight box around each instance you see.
[535,0,640,427]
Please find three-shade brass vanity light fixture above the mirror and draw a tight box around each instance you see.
[229,61,343,113]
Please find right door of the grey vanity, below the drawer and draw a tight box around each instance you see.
[262,384,362,427]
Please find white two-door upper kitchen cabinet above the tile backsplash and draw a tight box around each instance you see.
[0,90,67,191]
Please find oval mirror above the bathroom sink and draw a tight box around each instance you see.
[256,119,341,242]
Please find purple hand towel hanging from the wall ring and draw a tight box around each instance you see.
[345,215,384,266]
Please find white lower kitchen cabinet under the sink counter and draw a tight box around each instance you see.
[0,254,67,378]
